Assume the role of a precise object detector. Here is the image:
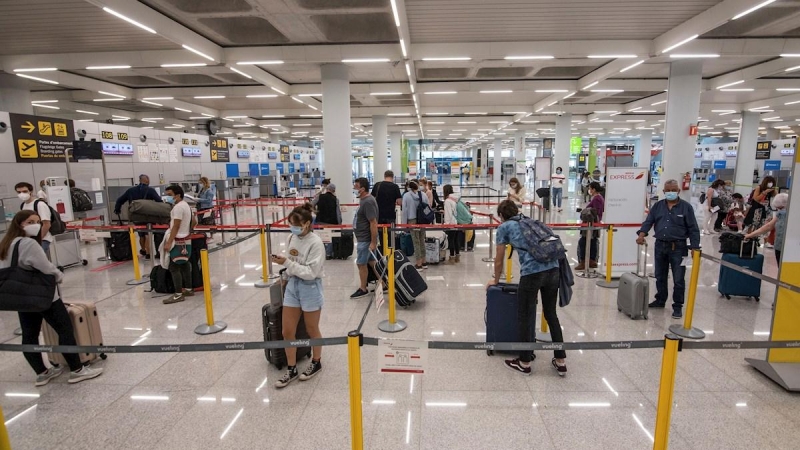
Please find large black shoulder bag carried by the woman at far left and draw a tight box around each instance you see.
[0,241,56,312]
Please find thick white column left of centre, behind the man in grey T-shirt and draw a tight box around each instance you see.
[322,64,353,188]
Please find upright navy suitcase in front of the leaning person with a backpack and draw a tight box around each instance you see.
[484,283,536,355]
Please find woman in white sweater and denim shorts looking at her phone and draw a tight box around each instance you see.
[272,203,326,388]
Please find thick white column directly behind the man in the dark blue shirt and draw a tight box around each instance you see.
[661,59,703,201]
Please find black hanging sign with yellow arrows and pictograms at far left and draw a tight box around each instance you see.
[9,113,75,162]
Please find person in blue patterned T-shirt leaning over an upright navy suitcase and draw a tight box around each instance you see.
[487,200,567,377]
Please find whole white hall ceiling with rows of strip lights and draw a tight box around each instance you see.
[0,0,800,151]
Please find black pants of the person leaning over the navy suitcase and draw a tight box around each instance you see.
[517,267,567,363]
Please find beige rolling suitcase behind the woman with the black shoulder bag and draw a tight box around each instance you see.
[42,303,106,367]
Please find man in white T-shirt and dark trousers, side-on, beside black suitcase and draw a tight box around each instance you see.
[163,185,194,305]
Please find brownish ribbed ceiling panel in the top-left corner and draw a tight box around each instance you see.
[0,0,180,55]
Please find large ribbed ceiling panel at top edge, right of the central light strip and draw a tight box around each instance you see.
[405,0,721,44]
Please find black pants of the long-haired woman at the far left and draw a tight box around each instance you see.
[17,299,82,375]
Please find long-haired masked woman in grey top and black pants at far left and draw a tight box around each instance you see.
[0,210,103,386]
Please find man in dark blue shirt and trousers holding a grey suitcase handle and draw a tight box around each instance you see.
[636,180,700,319]
